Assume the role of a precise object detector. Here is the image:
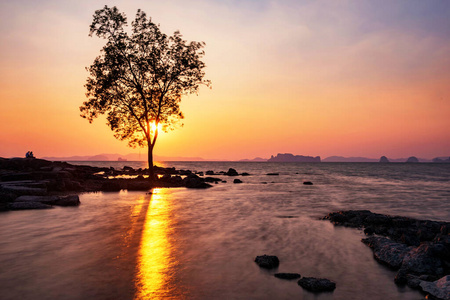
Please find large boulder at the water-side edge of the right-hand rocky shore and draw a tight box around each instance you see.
[361,236,411,270]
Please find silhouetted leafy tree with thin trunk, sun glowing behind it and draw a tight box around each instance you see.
[80,6,210,180]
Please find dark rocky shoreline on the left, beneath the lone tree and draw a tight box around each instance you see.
[0,158,243,211]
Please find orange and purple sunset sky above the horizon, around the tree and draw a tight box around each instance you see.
[0,0,450,160]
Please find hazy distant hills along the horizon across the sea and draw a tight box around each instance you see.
[39,153,450,163]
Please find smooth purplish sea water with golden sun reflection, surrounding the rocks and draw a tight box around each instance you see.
[0,162,450,300]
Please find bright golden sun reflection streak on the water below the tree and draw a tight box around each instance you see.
[135,189,176,299]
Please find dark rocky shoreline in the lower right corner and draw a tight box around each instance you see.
[323,210,450,300]
